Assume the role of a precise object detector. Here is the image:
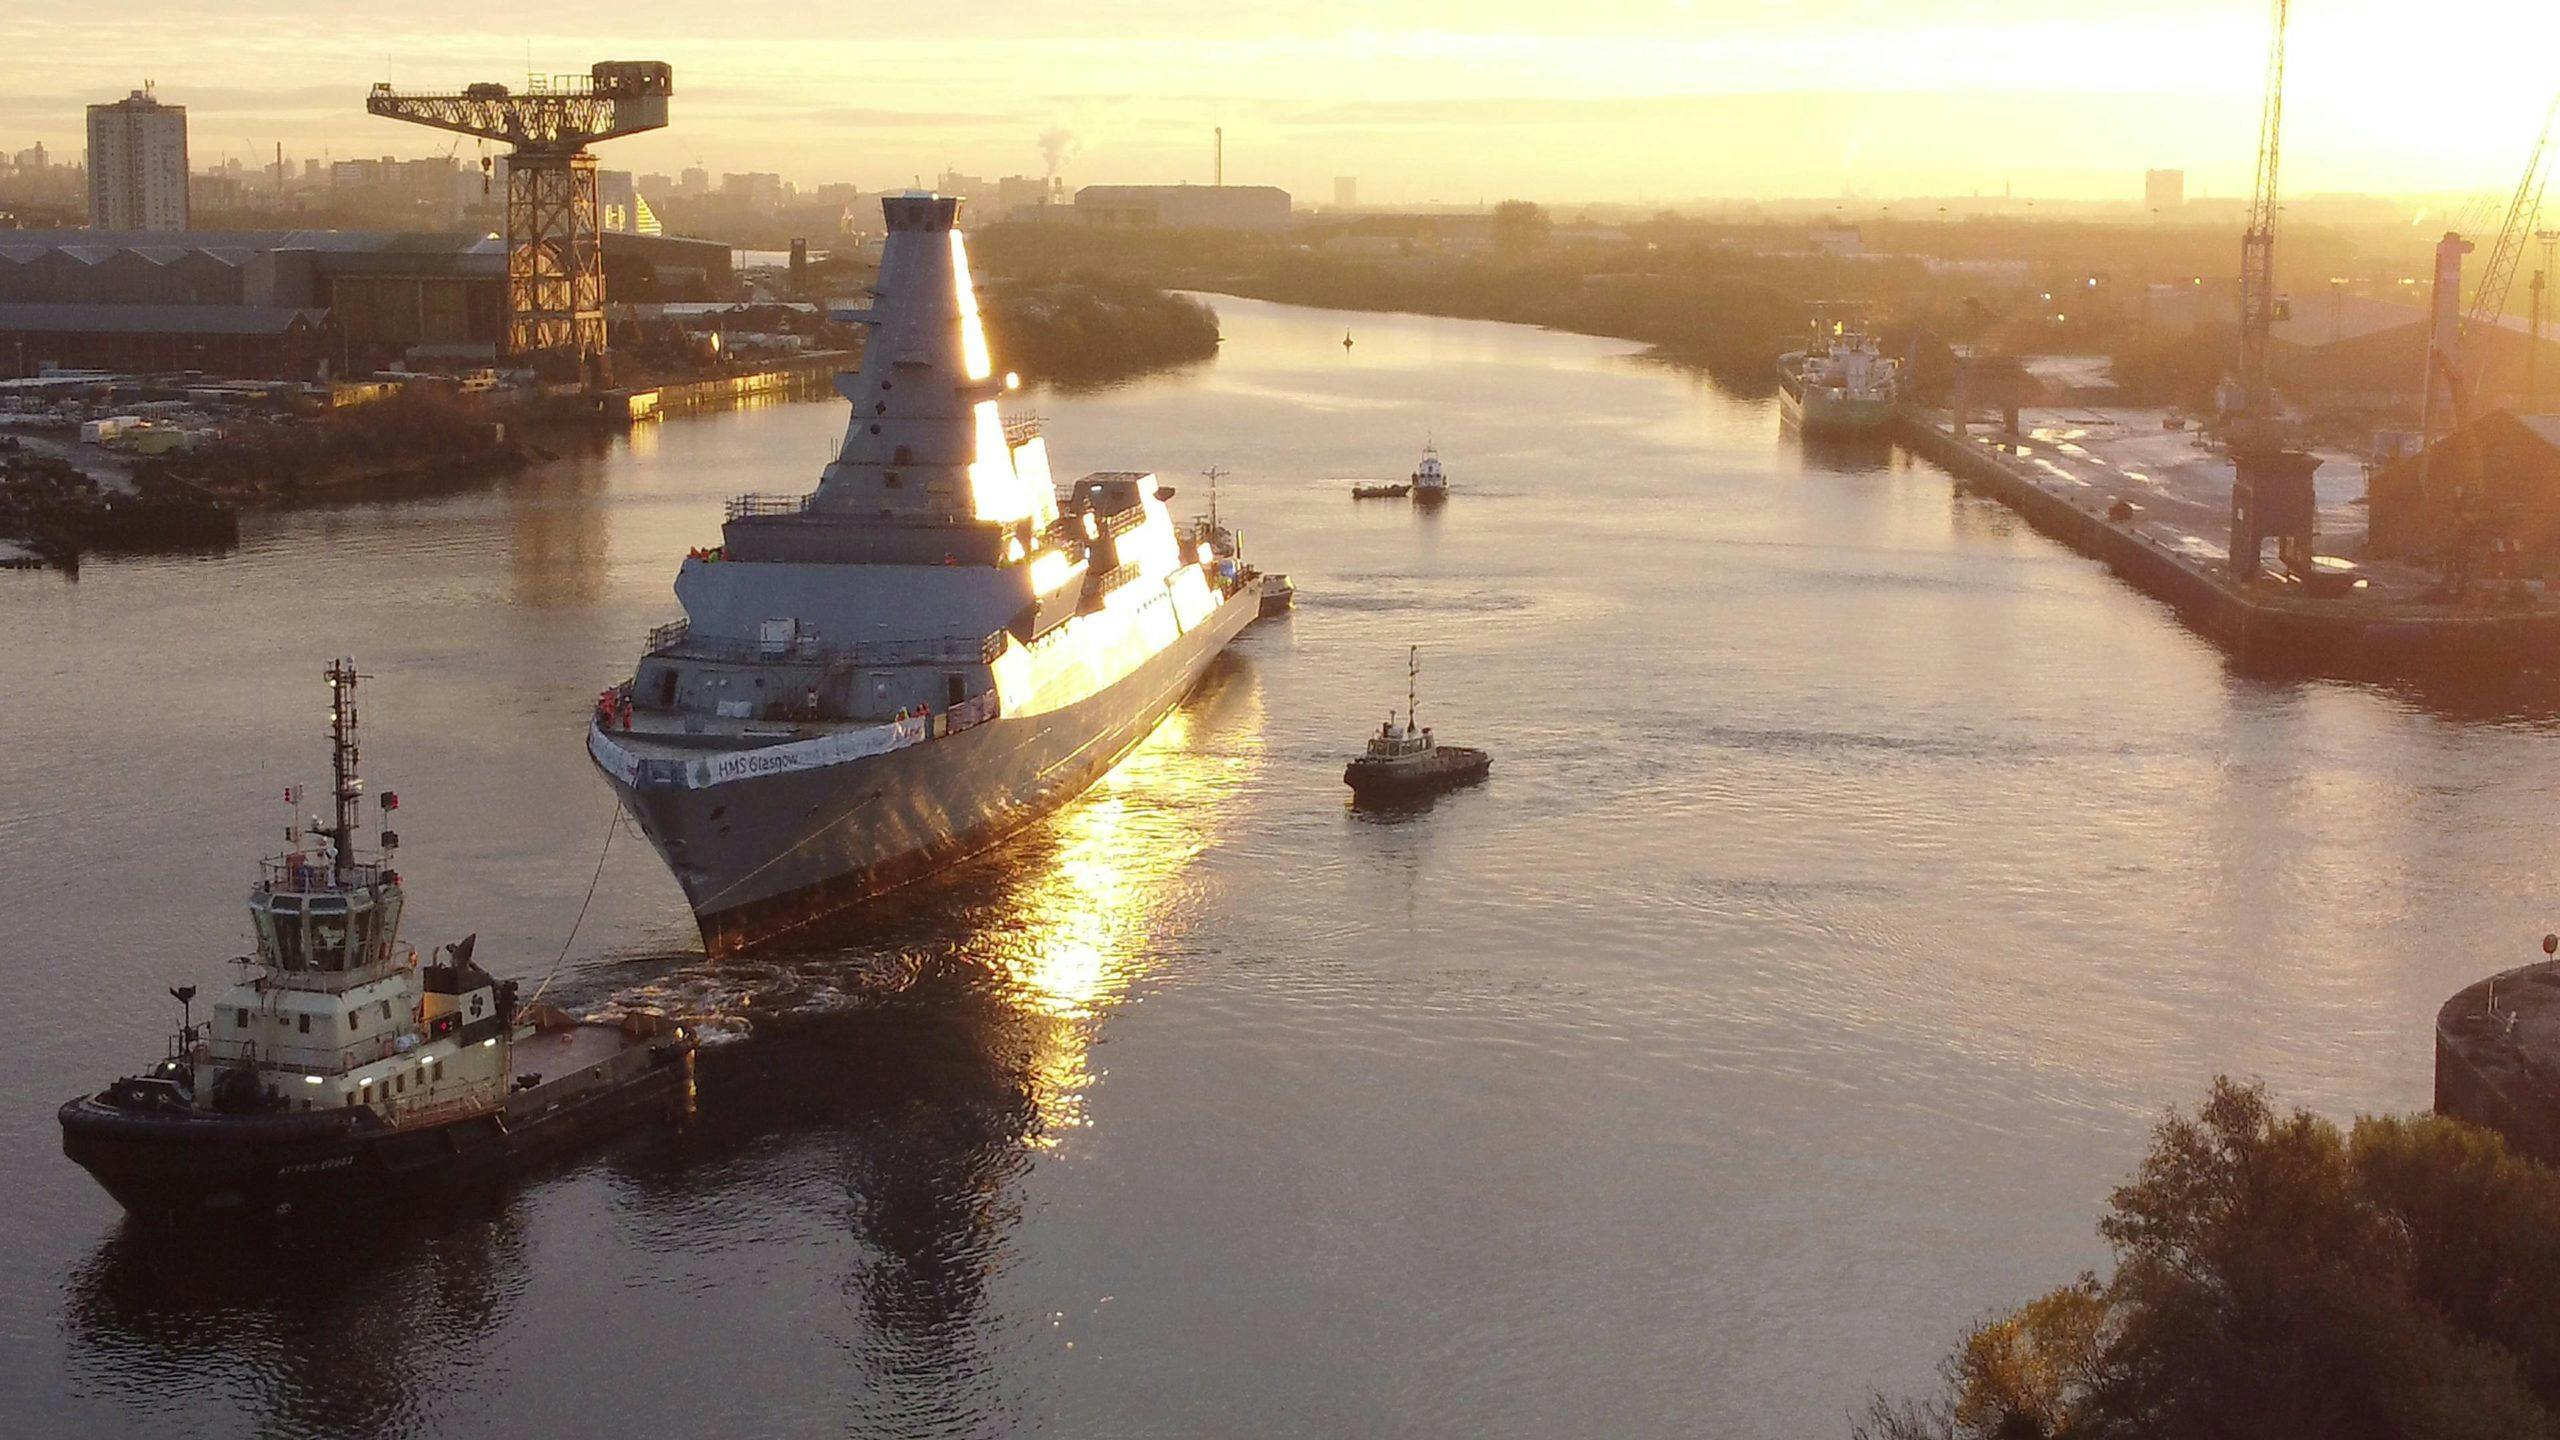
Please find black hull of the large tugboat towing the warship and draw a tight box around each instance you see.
[61,1043,694,1222]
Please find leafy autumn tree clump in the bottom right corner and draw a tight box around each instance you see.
[1859,1079,2560,1440]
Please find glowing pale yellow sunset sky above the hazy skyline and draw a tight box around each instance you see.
[0,0,2560,202]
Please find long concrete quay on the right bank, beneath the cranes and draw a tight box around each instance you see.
[1897,410,2560,676]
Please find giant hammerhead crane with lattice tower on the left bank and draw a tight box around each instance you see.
[364,59,676,369]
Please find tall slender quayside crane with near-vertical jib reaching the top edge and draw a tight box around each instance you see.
[2222,0,2319,584]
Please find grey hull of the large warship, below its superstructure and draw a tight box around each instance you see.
[589,587,1262,956]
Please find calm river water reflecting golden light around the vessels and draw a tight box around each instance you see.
[0,300,2555,1437]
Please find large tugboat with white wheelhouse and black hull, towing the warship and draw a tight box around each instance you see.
[61,659,694,1220]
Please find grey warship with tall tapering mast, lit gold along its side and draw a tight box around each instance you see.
[586,192,1262,953]
